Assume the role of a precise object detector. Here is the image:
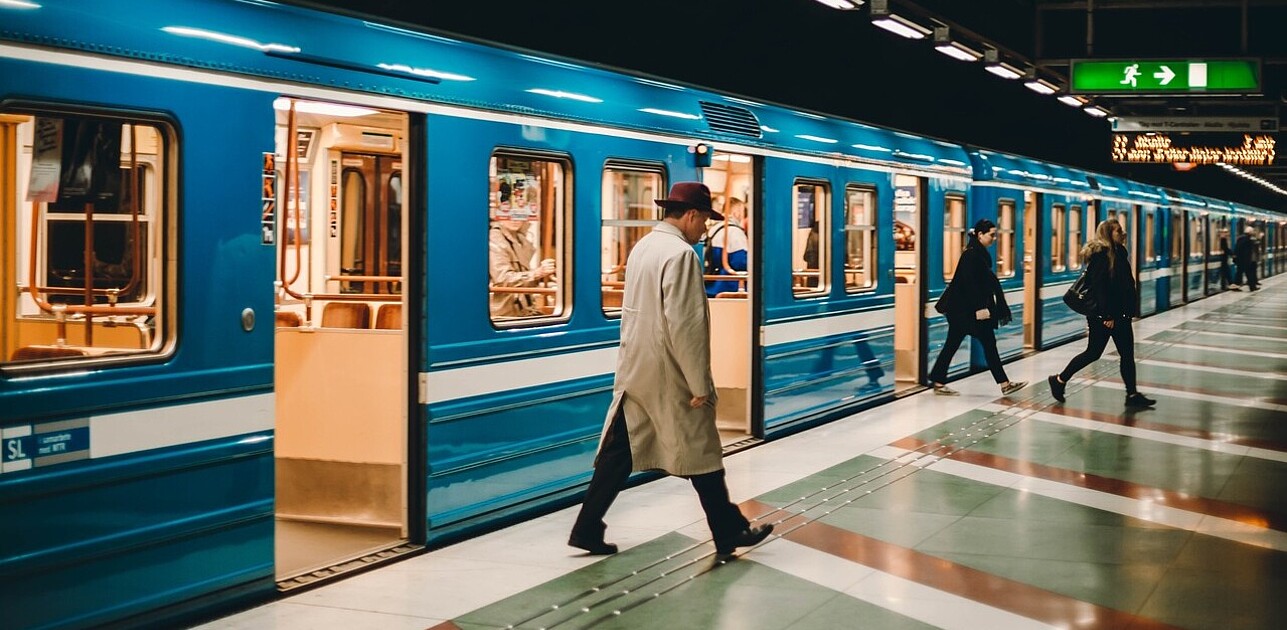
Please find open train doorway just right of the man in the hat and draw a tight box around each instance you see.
[701,152,761,446]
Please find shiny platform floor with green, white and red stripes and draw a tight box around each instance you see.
[201,276,1287,630]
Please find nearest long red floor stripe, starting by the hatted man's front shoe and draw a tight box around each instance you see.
[741,500,1172,629]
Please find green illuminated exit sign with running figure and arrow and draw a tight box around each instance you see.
[1068,59,1260,94]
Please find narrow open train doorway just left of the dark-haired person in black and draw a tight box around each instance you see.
[893,175,925,393]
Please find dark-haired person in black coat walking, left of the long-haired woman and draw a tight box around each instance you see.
[929,219,1028,396]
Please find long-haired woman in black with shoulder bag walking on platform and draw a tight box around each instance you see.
[1046,219,1157,409]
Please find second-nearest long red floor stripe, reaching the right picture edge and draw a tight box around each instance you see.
[892,437,1287,531]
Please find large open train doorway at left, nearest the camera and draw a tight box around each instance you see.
[264,98,418,590]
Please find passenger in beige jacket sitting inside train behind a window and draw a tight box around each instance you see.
[488,219,556,318]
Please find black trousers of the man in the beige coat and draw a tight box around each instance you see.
[571,404,750,546]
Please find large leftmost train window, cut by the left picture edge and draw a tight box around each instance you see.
[0,111,175,366]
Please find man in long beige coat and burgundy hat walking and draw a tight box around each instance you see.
[568,181,773,555]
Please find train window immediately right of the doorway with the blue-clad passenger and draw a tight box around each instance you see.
[790,181,831,297]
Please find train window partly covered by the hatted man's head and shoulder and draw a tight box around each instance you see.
[598,163,667,316]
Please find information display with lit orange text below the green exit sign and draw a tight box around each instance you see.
[1113,134,1277,166]
